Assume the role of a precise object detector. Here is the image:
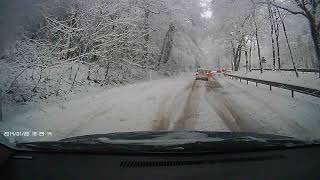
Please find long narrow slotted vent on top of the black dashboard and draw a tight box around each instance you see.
[120,155,284,168]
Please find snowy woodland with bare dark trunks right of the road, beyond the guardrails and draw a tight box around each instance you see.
[207,0,320,77]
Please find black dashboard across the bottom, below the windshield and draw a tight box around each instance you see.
[0,146,320,180]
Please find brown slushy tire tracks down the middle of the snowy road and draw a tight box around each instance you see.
[152,78,263,132]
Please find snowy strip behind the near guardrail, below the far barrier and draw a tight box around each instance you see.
[229,70,320,89]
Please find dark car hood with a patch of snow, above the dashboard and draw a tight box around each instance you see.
[13,131,314,153]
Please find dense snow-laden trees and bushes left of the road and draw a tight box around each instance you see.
[1,0,203,102]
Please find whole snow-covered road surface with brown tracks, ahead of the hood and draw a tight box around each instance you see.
[0,74,320,141]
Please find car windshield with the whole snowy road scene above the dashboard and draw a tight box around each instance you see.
[0,0,320,147]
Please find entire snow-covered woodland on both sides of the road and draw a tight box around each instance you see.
[0,0,320,105]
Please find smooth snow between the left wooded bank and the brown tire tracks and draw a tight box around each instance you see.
[0,73,190,141]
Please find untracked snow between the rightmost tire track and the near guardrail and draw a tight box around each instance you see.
[219,77,320,139]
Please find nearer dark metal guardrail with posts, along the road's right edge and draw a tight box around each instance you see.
[224,73,320,98]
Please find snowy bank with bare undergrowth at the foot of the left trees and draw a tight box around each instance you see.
[0,52,149,104]
